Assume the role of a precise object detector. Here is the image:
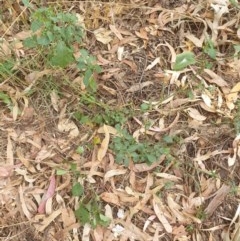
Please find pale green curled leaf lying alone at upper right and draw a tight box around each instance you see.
[173,51,196,71]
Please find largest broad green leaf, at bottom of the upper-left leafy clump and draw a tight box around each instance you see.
[50,42,74,68]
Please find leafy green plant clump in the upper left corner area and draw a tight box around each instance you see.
[24,8,101,90]
